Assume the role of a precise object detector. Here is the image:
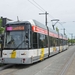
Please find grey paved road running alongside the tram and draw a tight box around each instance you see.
[0,46,75,75]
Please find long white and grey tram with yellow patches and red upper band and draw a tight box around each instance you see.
[2,20,68,64]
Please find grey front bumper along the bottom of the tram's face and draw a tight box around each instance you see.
[1,58,32,64]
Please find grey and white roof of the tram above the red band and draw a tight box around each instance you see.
[7,19,66,37]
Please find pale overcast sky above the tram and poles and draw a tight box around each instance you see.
[0,0,75,38]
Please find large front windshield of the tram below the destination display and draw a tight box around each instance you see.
[4,24,30,49]
